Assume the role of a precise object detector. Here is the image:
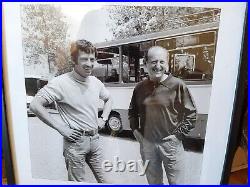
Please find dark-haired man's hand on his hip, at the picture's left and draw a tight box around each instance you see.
[58,126,82,142]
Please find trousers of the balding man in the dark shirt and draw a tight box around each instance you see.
[140,137,185,184]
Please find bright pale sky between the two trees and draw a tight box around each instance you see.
[61,3,111,43]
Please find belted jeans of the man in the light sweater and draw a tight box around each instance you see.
[63,134,106,183]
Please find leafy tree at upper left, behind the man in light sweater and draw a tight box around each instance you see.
[21,4,68,73]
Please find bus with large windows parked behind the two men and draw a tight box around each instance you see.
[94,22,218,140]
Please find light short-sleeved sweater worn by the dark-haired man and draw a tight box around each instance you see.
[36,71,109,131]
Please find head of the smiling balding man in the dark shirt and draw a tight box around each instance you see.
[147,48,169,80]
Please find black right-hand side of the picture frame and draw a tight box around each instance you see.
[220,10,248,184]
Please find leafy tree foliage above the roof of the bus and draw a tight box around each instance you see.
[106,5,219,39]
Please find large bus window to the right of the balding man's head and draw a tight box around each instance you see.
[156,31,216,80]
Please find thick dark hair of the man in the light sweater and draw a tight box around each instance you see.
[70,40,97,63]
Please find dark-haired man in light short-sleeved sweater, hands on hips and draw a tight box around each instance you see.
[30,40,112,183]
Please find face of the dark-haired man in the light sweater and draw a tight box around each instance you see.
[75,51,96,77]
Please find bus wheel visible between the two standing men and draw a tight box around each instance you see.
[107,113,122,136]
